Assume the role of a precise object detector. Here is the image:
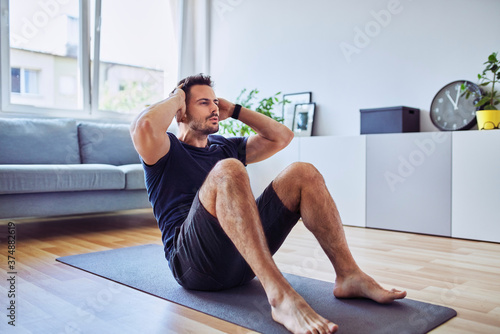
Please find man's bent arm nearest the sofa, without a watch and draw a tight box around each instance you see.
[130,87,186,165]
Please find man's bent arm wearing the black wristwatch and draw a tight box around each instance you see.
[219,99,294,164]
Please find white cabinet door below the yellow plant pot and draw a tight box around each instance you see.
[452,130,500,242]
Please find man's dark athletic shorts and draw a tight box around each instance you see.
[169,184,300,290]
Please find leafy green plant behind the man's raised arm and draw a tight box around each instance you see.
[219,88,290,136]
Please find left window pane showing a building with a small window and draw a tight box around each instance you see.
[8,0,83,110]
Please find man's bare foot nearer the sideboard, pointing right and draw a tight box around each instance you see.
[333,271,406,304]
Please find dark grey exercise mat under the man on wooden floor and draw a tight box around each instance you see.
[57,245,457,334]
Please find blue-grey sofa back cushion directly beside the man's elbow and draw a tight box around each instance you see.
[78,122,140,166]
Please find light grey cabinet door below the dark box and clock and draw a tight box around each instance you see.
[366,132,451,236]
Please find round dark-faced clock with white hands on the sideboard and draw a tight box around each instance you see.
[430,80,482,131]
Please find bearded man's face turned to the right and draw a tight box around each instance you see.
[186,85,219,134]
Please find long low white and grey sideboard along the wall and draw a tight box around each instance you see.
[247,130,500,242]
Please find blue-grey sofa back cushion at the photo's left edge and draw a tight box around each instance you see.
[0,118,80,164]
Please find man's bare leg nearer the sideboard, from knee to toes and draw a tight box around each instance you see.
[273,163,406,303]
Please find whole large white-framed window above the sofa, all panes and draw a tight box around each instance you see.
[0,0,177,117]
